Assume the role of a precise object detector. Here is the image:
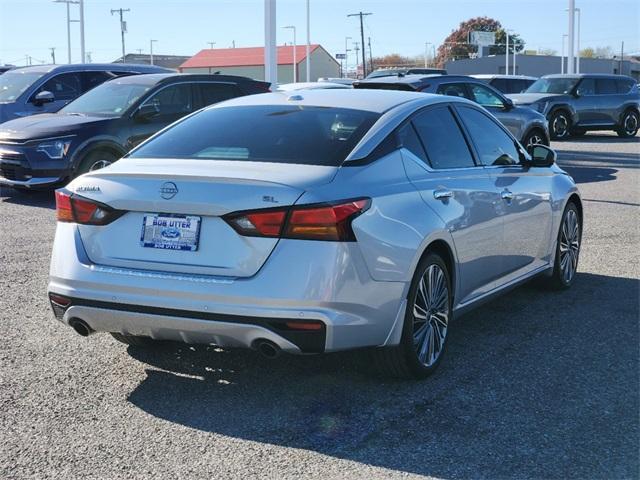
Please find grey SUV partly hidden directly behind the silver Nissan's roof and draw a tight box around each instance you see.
[353,75,549,149]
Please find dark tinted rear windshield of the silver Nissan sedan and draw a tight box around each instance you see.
[130,105,380,166]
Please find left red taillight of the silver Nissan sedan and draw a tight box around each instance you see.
[56,189,124,225]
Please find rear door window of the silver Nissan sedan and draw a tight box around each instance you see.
[412,106,475,169]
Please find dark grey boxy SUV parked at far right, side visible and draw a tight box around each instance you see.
[507,74,640,140]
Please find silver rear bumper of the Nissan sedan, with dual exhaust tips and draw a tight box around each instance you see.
[49,224,406,353]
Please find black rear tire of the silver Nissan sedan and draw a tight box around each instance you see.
[371,253,453,379]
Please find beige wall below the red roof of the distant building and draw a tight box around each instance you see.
[182,48,340,83]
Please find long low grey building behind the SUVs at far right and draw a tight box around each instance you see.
[445,55,640,79]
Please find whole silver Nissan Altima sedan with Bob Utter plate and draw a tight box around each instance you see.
[48,90,582,378]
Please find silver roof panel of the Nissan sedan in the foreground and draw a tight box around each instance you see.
[208,88,452,114]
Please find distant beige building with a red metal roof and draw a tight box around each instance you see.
[178,45,340,83]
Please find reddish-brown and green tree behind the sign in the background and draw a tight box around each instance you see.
[436,17,525,68]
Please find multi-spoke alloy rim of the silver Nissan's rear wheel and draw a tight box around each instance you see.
[413,265,450,367]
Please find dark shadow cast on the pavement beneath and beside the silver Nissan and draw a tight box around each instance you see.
[128,273,640,479]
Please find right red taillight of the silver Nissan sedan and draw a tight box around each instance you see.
[225,198,371,242]
